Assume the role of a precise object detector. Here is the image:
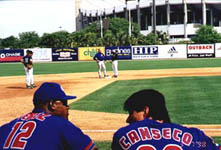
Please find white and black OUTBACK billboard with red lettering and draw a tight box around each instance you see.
[187,44,215,58]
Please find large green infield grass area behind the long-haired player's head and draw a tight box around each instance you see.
[70,76,221,124]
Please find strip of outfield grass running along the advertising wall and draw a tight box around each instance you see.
[0,58,221,76]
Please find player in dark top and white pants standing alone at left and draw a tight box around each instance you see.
[21,50,36,89]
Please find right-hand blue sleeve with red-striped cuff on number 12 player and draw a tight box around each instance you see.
[59,121,94,150]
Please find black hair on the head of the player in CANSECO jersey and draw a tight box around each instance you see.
[124,89,171,123]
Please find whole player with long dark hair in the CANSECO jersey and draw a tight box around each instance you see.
[112,89,221,150]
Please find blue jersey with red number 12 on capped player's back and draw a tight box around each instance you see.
[0,109,91,150]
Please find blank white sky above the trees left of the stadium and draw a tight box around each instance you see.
[0,0,76,39]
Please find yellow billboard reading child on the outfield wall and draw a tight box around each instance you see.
[78,47,105,61]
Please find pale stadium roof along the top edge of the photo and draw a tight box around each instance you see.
[80,0,221,16]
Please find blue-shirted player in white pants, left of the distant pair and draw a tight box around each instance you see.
[93,49,108,79]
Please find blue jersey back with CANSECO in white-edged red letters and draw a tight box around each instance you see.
[112,119,219,150]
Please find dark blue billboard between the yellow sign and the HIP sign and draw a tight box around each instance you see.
[105,46,132,59]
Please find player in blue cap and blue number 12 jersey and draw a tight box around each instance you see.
[0,82,97,150]
